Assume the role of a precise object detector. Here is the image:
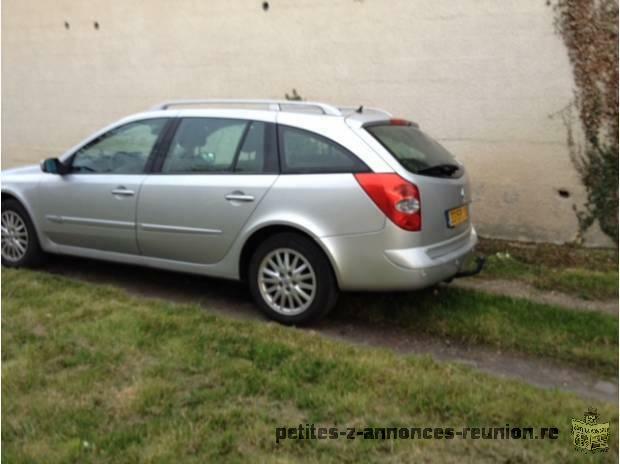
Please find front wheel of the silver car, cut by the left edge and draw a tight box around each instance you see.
[1,200,44,267]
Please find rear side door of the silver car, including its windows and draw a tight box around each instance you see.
[137,117,278,264]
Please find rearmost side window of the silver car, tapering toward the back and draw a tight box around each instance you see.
[278,126,368,173]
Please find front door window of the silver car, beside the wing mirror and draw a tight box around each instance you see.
[71,118,168,174]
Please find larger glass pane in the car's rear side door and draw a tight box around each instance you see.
[162,118,249,173]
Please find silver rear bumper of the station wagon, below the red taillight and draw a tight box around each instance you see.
[322,227,478,291]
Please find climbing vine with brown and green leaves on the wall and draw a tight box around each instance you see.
[553,0,618,245]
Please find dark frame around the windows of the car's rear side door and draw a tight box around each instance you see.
[148,116,280,176]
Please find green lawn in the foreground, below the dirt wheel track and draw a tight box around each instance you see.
[2,270,618,463]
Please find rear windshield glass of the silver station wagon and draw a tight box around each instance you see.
[366,123,462,177]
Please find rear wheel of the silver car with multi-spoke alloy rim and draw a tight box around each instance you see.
[248,232,338,325]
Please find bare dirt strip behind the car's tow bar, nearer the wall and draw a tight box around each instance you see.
[450,279,618,316]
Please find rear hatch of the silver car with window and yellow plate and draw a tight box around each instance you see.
[358,119,471,246]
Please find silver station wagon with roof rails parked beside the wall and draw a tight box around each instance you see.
[2,100,483,324]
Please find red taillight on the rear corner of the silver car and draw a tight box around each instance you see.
[355,173,422,231]
